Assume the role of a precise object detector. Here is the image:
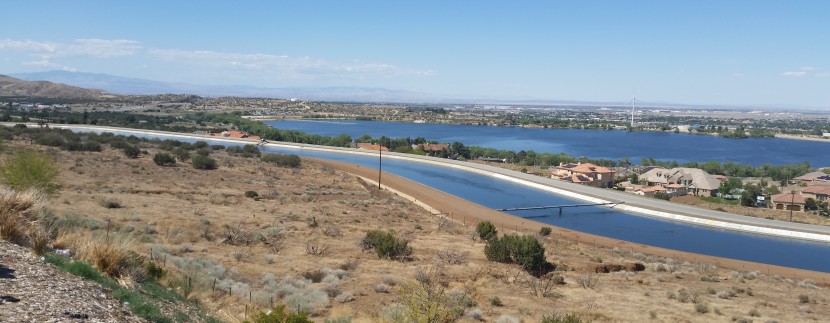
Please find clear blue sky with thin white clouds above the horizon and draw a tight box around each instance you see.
[0,0,830,109]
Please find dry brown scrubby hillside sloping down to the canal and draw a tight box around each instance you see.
[0,129,830,322]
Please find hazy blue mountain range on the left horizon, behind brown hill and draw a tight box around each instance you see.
[10,71,436,102]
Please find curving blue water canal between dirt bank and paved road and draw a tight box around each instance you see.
[53,127,830,272]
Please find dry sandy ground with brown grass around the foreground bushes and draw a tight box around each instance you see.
[6,141,830,322]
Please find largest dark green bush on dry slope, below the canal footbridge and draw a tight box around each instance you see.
[484,234,553,276]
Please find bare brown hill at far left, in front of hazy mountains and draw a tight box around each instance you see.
[0,75,110,99]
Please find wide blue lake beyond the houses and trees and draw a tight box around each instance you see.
[265,120,830,167]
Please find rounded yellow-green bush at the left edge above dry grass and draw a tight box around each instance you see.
[0,150,60,194]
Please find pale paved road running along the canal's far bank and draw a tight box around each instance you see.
[13,123,830,241]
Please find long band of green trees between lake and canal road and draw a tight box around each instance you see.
[3,111,812,181]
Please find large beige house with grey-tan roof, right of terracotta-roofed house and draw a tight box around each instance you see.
[638,167,725,196]
